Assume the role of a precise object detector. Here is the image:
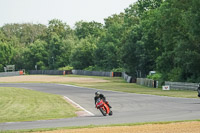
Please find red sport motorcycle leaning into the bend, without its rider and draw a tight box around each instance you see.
[96,98,113,116]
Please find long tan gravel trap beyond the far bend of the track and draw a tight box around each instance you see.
[0,75,109,83]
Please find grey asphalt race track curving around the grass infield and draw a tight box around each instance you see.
[0,83,200,131]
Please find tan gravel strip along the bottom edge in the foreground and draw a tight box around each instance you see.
[33,122,200,133]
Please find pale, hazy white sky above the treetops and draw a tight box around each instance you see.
[0,0,137,27]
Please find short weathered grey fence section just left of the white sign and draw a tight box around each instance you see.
[136,78,158,88]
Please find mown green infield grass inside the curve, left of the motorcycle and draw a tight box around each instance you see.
[0,87,76,122]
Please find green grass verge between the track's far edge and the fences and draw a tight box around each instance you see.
[64,75,198,98]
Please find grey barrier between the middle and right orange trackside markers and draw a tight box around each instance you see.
[72,70,112,77]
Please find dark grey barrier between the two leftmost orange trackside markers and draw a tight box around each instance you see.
[29,70,65,75]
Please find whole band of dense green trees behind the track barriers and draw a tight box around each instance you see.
[0,0,200,82]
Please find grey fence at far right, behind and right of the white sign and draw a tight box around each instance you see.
[165,81,198,90]
